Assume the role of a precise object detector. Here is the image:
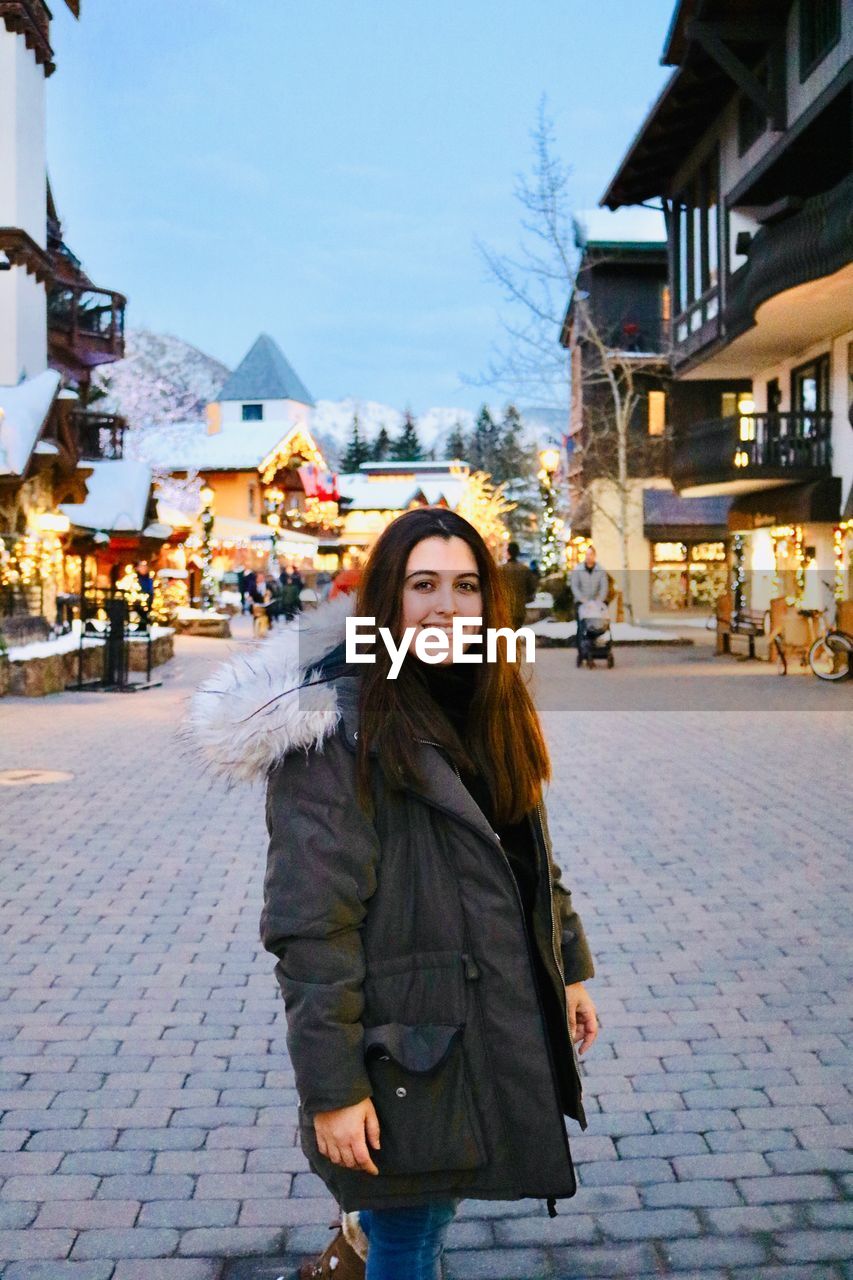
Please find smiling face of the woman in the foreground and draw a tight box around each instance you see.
[402,538,483,666]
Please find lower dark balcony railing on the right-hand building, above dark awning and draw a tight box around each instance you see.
[671,411,833,489]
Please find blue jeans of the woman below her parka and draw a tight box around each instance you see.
[359,1199,460,1280]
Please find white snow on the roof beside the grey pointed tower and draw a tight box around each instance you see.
[131,419,293,471]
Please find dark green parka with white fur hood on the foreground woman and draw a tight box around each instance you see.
[193,600,594,1210]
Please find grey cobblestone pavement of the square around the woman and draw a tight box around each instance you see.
[0,640,853,1280]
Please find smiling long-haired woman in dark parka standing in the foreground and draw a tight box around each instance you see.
[189,508,597,1280]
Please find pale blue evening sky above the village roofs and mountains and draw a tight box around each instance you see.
[47,0,674,412]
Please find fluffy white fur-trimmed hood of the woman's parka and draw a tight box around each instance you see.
[186,595,355,782]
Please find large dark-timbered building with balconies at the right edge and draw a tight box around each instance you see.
[602,0,853,609]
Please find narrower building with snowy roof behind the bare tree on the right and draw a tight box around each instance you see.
[561,214,738,618]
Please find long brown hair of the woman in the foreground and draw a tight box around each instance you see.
[357,507,551,822]
